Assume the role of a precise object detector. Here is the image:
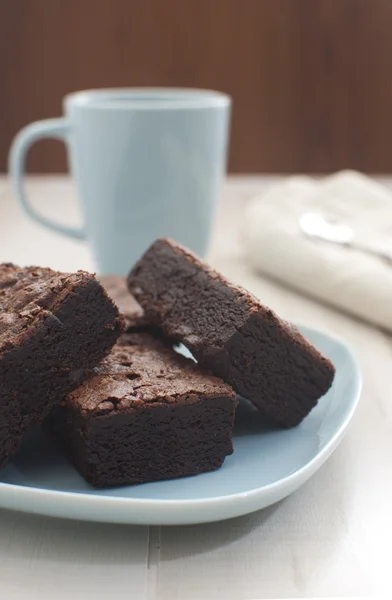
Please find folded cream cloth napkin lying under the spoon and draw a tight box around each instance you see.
[243,171,392,331]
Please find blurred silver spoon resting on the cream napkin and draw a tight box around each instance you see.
[299,212,392,264]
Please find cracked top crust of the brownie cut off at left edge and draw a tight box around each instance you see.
[0,263,123,353]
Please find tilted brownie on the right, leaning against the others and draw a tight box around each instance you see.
[128,239,334,427]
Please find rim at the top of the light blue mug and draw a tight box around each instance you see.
[63,87,231,111]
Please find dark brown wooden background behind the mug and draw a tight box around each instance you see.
[0,0,392,173]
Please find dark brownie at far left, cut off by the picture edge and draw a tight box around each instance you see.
[0,263,124,465]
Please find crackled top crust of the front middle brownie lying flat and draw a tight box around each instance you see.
[66,333,235,414]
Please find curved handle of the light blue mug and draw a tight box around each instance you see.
[9,118,86,240]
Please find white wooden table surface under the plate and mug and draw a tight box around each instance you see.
[0,177,392,600]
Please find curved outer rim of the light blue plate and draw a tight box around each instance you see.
[0,323,362,524]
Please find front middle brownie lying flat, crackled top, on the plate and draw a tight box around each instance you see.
[49,333,236,487]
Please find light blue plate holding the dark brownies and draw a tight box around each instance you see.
[0,327,361,525]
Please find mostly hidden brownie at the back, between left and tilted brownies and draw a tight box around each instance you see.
[99,275,147,331]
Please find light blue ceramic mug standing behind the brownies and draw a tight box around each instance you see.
[9,88,230,275]
